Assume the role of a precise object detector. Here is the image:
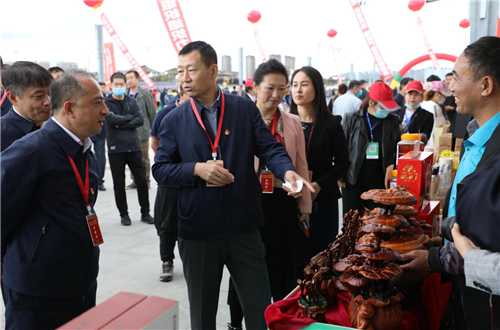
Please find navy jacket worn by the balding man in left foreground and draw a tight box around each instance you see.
[1,119,100,298]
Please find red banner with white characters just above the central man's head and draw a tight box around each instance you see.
[157,0,191,54]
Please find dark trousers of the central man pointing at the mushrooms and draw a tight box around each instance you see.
[179,229,271,330]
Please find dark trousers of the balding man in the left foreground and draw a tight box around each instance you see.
[3,285,97,330]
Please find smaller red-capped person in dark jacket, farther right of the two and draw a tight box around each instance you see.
[396,80,434,144]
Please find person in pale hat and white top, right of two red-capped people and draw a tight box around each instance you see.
[422,81,451,146]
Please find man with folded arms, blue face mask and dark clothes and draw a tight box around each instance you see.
[105,72,154,226]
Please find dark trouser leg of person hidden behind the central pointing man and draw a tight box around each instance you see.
[154,186,179,262]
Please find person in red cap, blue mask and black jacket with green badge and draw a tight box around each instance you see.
[341,82,401,214]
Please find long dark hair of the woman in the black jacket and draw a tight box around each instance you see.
[290,66,332,127]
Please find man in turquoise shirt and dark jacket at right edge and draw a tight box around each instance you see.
[400,37,500,329]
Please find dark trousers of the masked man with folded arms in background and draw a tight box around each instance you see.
[108,151,149,217]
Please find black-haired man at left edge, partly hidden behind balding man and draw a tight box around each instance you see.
[0,61,53,151]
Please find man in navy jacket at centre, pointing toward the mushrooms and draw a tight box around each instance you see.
[153,41,314,330]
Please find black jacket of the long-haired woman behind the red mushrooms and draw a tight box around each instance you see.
[307,115,351,202]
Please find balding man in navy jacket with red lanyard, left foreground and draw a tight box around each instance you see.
[1,73,108,330]
